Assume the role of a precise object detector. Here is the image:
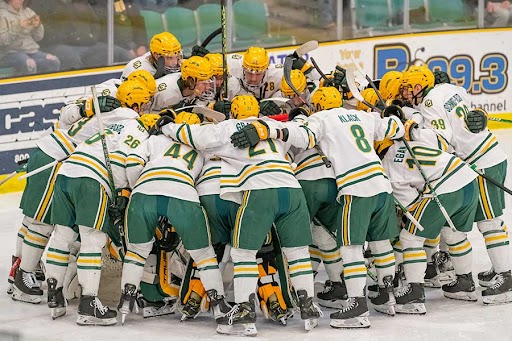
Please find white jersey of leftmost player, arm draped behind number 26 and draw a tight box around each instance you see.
[36,108,139,160]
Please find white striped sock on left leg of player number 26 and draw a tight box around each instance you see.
[46,225,78,287]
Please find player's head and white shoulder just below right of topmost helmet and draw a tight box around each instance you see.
[151,56,215,112]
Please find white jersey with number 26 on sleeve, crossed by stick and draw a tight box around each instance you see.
[59,109,148,199]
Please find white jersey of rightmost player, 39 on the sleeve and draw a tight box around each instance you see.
[412,84,507,169]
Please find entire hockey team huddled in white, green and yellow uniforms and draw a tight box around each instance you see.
[8,32,512,335]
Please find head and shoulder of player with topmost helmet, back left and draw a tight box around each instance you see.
[121,32,183,80]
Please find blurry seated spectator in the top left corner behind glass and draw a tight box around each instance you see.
[0,0,60,75]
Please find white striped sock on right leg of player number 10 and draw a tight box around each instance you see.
[441,227,473,275]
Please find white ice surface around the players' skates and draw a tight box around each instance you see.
[0,130,512,341]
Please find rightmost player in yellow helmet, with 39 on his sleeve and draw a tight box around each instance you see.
[400,66,512,304]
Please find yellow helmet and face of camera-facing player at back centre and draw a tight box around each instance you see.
[242,46,270,91]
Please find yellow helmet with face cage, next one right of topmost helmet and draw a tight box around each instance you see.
[181,56,216,102]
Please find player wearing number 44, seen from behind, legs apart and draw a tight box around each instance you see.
[118,112,230,322]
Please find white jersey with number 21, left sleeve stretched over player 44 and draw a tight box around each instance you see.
[162,118,307,202]
